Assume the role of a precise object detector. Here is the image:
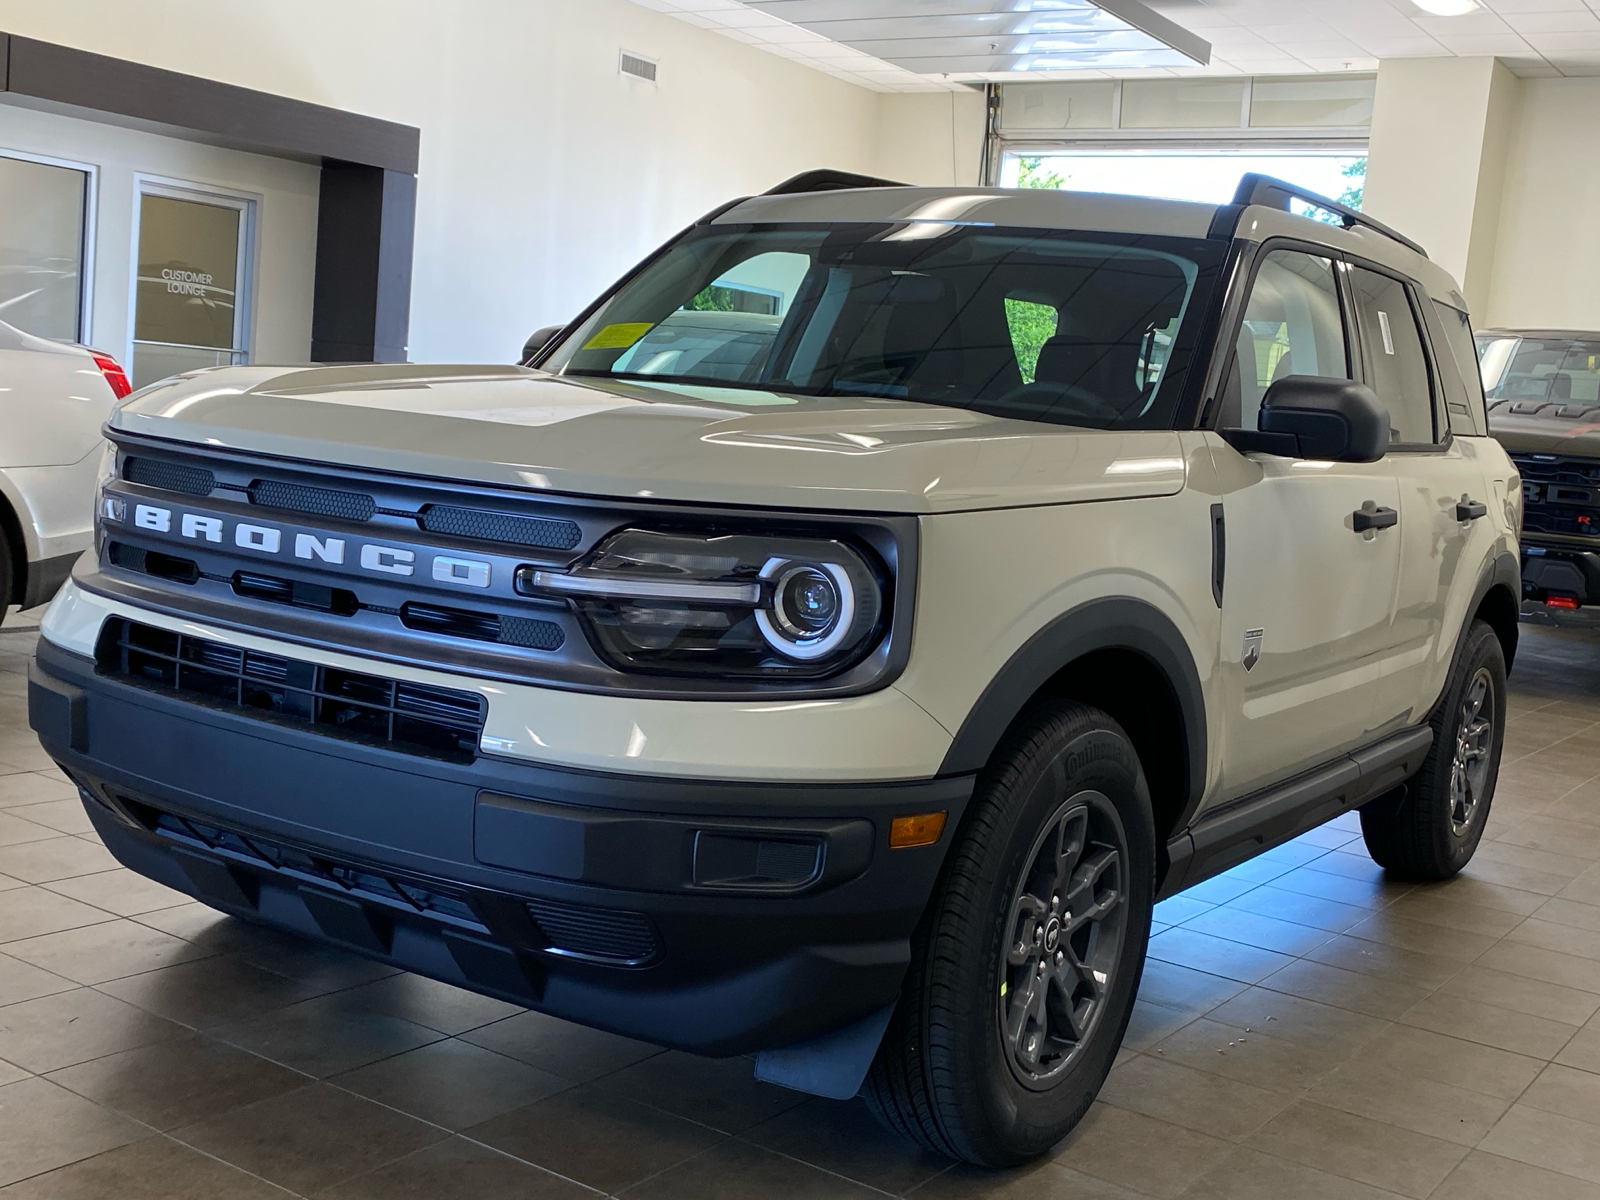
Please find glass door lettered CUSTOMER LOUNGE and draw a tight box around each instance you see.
[130,182,254,387]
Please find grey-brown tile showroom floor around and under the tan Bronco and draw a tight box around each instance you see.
[0,614,1600,1200]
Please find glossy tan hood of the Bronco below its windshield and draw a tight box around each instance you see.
[110,365,1186,512]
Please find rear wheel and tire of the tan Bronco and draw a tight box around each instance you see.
[1362,621,1506,880]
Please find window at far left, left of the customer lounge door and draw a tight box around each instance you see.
[0,155,91,341]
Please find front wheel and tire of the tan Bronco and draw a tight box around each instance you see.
[862,702,1155,1166]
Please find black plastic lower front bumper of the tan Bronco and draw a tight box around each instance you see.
[29,640,973,1054]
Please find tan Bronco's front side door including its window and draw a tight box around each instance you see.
[1208,250,1402,798]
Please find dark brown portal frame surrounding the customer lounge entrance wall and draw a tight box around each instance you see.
[0,32,422,363]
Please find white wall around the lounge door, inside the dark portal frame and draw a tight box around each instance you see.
[0,104,318,365]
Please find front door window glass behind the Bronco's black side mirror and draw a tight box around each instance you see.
[1219,250,1350,429]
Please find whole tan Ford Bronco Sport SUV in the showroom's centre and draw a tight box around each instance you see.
[29,173,1522,1165]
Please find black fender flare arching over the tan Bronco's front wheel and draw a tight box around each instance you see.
[939,597,1206,829]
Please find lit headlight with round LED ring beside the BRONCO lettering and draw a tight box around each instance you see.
[517,530,886,677]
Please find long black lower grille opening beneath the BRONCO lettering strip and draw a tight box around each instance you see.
[94,618,486,762]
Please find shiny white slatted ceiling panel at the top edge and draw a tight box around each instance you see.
[732,0,1211,77]
